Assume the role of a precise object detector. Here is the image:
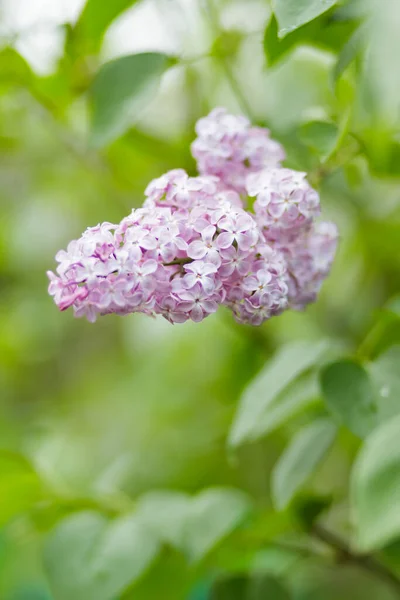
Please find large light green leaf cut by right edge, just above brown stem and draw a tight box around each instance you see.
[351,416,400,552]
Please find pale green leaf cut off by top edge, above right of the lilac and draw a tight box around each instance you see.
[272,0,336,38]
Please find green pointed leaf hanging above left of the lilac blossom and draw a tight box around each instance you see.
[90,52,174,146]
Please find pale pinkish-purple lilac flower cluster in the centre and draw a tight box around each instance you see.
[48,109,337,325]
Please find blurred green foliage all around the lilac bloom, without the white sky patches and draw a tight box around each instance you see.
[0,0,400,600]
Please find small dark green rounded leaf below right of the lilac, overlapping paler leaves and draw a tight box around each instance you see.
[321,360,377,437]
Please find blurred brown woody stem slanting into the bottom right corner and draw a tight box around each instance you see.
[311,525,400,594]
